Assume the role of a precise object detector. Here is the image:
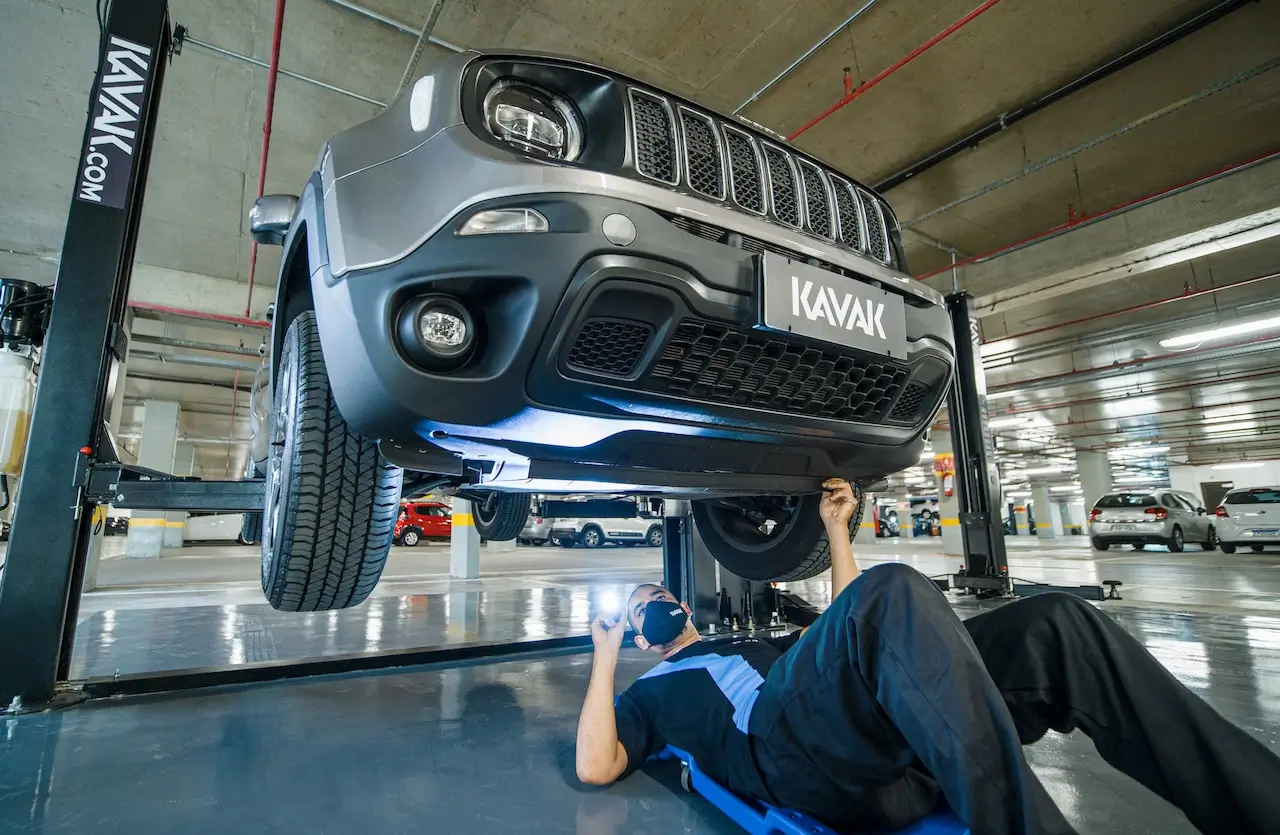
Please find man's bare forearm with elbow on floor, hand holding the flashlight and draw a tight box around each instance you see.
[576,617,627,785]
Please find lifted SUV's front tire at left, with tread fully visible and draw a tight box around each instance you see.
[262,311,403,612]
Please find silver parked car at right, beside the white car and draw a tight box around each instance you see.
[1089,490,1217,552]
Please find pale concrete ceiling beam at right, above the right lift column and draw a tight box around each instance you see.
[957,160,1280,316]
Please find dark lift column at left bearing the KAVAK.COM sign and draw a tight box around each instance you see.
[0,0,170,704]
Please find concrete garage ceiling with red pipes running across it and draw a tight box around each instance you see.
[0,0,1280,476]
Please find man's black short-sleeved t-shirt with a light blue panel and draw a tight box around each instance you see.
[614,630,800,798]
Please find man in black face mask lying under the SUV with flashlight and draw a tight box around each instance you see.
[577,479,1280,835]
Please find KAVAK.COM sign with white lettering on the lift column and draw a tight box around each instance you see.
[76,36,152,209]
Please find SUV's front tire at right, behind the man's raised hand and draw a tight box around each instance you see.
[692,488,867,581]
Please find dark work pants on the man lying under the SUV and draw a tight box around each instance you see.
[750,563,1280,835]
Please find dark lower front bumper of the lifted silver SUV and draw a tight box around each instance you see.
[312,148,952,492]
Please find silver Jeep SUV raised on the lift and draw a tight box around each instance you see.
[251,53,954,611]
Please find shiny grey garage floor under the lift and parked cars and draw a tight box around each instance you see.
[0,543,1280,835]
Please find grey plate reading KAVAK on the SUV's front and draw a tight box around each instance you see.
[759,252,906,360]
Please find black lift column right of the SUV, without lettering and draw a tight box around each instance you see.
[940,293,1011,597]
